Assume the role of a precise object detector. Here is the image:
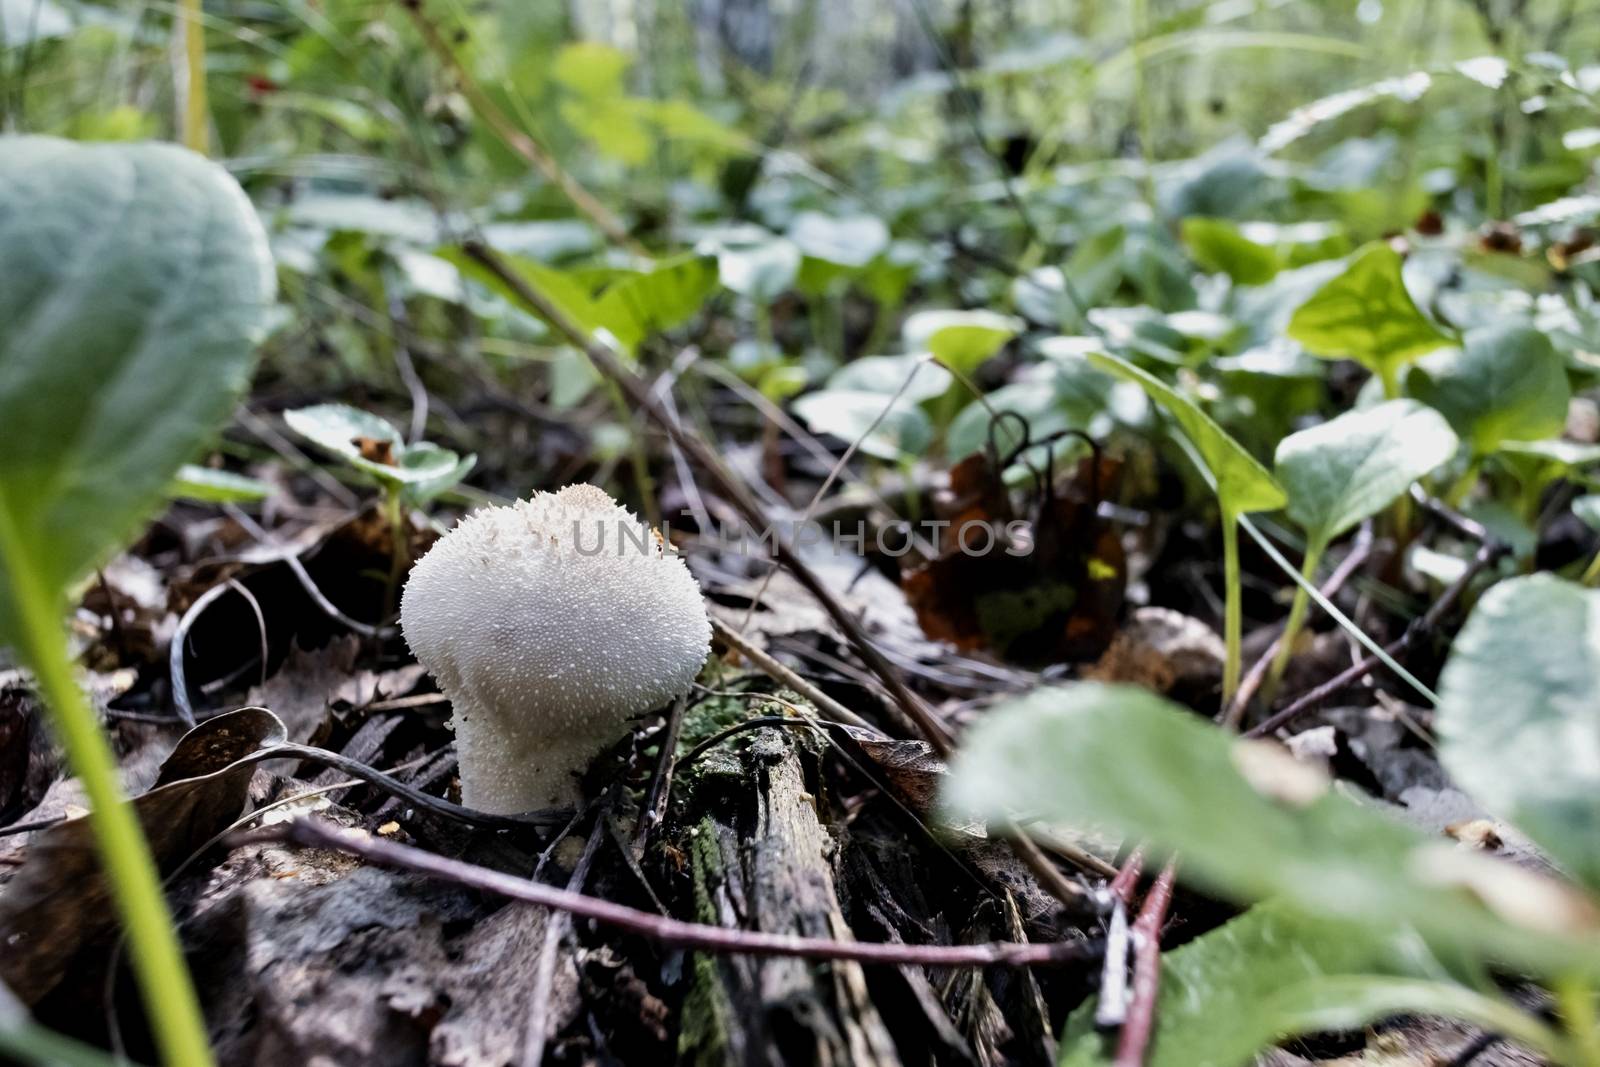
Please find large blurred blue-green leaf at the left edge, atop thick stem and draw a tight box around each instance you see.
[0,138,274,640]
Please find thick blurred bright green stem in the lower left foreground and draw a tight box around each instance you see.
[0,501,214,1067]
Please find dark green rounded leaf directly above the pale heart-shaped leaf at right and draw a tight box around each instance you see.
[1408,323,1573,456]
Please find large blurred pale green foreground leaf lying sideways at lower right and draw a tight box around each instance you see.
[947,683,1600,974]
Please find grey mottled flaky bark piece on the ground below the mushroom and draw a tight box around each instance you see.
[187,825,579,1067]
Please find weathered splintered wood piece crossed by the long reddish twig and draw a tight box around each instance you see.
[678,731,899,1067]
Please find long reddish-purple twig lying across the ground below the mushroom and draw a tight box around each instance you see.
[240,819,1099,966]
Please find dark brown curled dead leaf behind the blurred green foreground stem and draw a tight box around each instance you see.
[0,707,285,1005]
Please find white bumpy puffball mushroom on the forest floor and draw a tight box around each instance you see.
[400,485,710,814]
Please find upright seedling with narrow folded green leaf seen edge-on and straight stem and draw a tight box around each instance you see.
[1088,352,1288,707]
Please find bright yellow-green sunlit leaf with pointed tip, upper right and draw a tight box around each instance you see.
[1288,242,1450,388]
